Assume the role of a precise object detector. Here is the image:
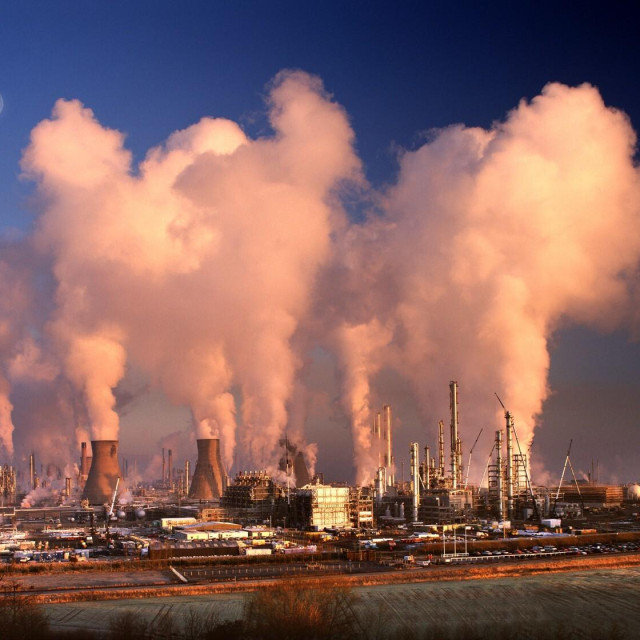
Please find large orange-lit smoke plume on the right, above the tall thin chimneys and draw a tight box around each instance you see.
[330,84,640,477]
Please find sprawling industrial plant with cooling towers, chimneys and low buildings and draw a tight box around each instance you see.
[0,381,640,559]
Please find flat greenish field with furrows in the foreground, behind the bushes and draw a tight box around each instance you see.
[42,566,640,639]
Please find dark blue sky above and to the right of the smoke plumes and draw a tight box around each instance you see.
[0,0,640,479]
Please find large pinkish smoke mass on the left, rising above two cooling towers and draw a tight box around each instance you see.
[18,73,360,476]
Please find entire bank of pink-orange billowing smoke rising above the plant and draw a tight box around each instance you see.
[0,72,640,482]
